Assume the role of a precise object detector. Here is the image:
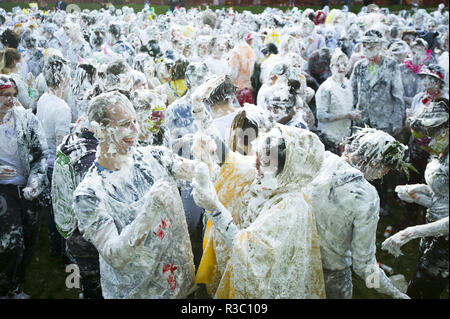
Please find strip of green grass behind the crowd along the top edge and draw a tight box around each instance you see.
[0,2,442,14]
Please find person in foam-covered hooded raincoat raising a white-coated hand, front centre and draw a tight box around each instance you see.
[193,124,325,299]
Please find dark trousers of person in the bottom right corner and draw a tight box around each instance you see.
[406,236,448,299]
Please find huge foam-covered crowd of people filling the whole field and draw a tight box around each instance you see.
[0,4,449,299]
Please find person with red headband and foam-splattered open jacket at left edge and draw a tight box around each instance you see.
[0,75,49,298]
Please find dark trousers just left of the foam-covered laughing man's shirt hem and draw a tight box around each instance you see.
[66,228,102,299]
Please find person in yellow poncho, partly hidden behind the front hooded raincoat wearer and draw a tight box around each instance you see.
[195,104,274,296]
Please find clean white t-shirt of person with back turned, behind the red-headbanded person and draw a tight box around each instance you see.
[36,92,72,167]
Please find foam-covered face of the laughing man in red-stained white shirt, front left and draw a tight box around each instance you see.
[104,104,139,155]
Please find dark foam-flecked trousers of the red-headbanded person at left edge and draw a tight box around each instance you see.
[0,185,41,297]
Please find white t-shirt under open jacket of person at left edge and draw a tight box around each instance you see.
[0,121,27,186]
